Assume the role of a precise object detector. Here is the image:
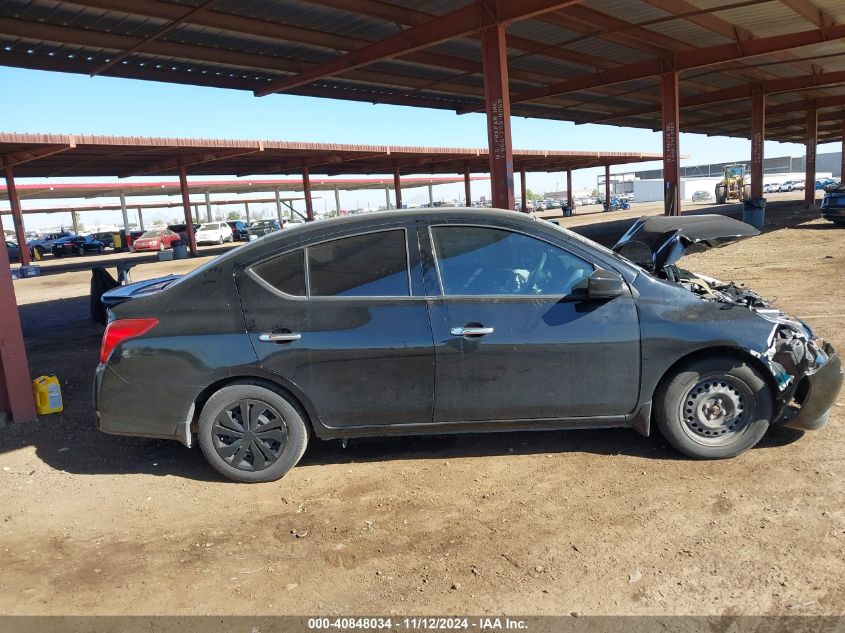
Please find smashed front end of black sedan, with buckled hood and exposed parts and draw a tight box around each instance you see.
[613,215,843,430]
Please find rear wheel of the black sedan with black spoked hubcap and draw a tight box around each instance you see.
[198,381,308,483]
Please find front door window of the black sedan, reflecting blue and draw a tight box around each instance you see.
[431,226,594,296]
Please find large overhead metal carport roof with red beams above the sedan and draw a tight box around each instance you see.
[0,0,845,142]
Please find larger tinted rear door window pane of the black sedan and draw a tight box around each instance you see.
[307,229,411,297]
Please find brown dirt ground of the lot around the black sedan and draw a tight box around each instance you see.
[0,195,845,615]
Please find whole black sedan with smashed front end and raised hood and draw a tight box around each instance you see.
[95,209,842,482]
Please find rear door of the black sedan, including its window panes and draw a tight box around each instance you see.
[238,223,434,428]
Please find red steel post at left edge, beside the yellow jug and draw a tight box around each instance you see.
[0,225,37,422]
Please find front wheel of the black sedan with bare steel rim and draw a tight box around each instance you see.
[654,356,774,459]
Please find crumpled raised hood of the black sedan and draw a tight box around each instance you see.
[613,215,760,272]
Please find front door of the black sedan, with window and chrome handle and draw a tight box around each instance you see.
[420,223,640,424]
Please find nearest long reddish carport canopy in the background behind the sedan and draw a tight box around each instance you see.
[0,133,662,179]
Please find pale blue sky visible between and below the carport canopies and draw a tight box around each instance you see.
[0,68,838,228]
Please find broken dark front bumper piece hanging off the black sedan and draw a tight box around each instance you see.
[780,344,845,431]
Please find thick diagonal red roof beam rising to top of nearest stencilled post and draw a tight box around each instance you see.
[255,0,581,97]
